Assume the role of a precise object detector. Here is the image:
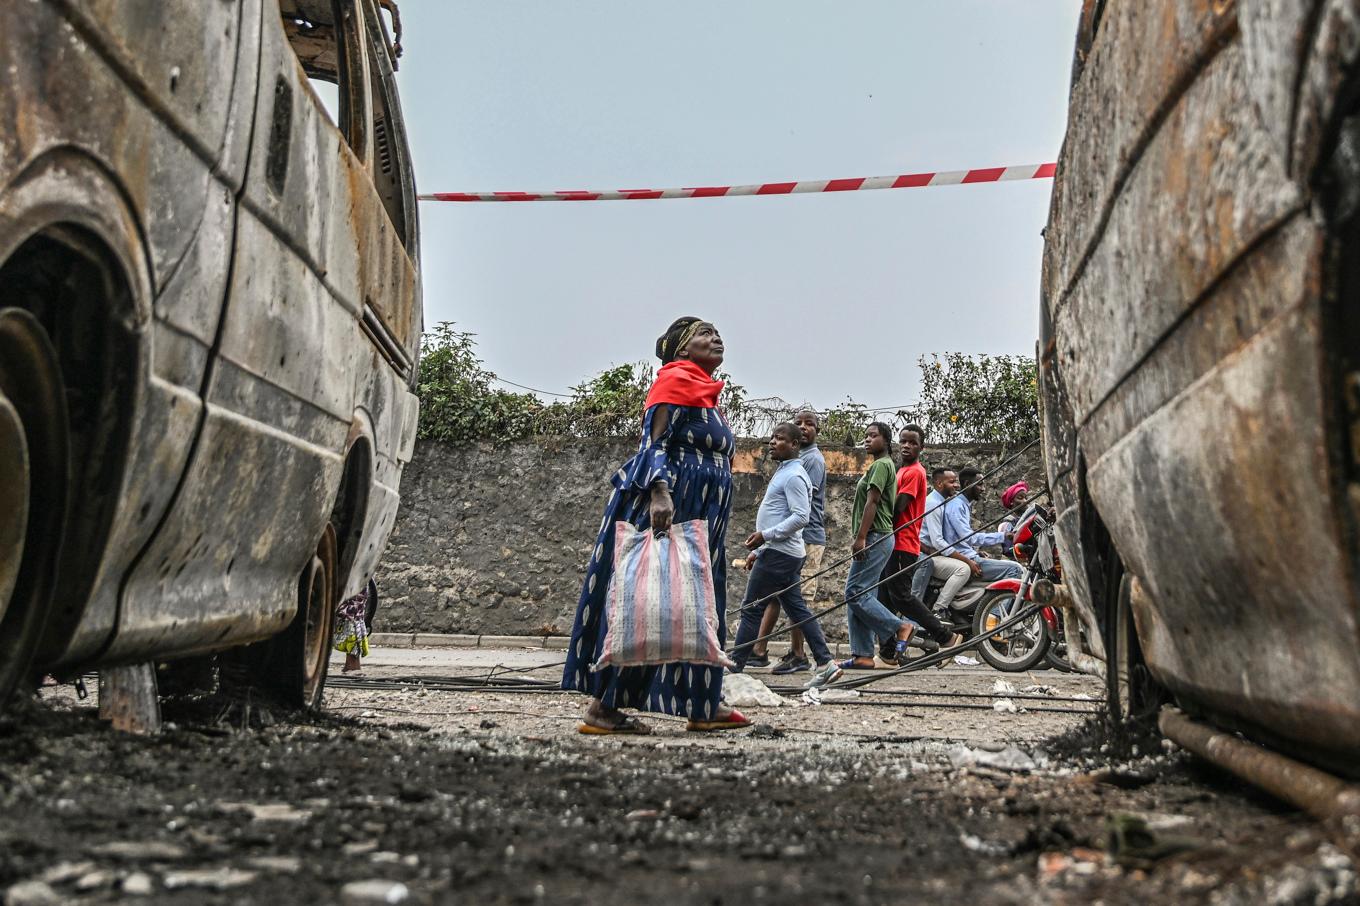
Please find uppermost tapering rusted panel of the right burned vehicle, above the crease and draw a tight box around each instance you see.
[1044,0,1236,310]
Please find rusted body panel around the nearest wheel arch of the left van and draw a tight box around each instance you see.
[0,0,258,658]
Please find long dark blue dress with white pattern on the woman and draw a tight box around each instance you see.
[562,403,736,720]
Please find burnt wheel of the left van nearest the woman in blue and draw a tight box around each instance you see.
[243,524,339,709]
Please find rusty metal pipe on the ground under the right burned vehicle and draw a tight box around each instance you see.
[1157,705,1360,820]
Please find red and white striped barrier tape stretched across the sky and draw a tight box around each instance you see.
[418,163,1058,201]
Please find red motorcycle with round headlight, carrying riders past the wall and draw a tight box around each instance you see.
[971,506,1072,673]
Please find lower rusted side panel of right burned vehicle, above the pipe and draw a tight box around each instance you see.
[1091,266,1360,754]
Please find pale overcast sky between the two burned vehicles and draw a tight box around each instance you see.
[398,0,1080,407]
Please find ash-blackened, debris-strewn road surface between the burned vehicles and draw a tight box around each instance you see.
[0,649,1360,905]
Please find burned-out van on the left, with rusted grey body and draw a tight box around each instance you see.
[0,0,422,705]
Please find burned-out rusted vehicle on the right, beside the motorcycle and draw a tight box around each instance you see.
[1039,0,1360,777]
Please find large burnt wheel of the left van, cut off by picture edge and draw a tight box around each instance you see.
[0,309,68,707]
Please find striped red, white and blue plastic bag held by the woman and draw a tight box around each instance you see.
[592,520,733,671]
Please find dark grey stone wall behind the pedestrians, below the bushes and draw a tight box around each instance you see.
[377,438,1042,635]
